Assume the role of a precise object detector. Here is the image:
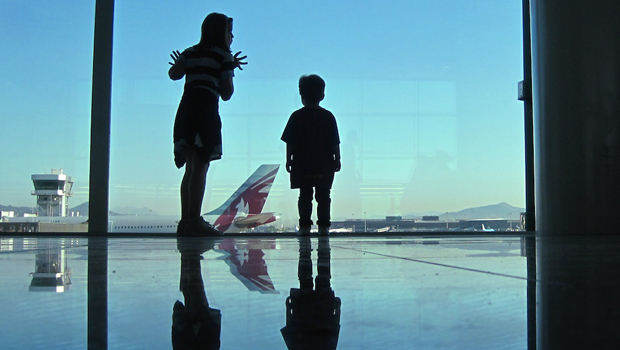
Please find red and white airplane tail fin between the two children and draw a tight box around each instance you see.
[203,164,280,232]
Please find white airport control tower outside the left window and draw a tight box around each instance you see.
[31,169,73,216]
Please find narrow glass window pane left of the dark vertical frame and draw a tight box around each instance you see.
[0,0,95,224]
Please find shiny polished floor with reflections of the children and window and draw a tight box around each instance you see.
[0,236,620,350]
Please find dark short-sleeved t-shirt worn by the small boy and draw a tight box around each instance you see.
[281,107,340,188]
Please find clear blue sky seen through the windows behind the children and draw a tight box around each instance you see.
[0,0,524,224]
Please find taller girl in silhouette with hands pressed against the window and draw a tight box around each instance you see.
[168,13,247,236]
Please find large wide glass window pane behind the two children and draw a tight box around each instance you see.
[110,0,525,231]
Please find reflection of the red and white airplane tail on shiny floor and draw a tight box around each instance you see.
[215,239,279,294]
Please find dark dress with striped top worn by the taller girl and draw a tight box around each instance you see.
[173,46,235,168]
